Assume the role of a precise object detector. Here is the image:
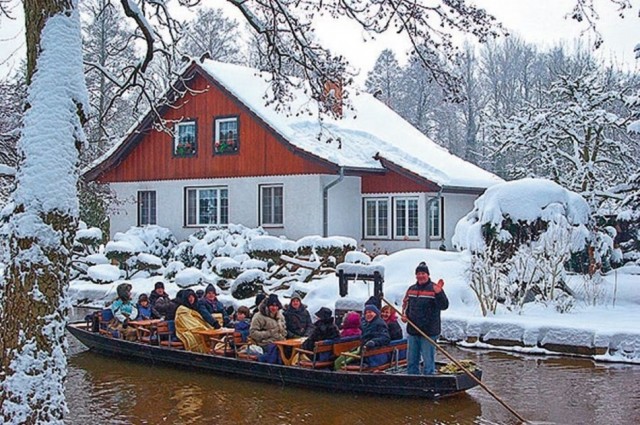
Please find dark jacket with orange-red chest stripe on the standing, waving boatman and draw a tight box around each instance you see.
[402,279,449,336]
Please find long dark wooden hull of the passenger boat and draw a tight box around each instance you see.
[67,322,482,399]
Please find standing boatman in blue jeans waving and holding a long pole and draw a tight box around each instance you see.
[402,261,449,375]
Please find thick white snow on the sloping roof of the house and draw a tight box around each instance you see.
[201,60,503,188]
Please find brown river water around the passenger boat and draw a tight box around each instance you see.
[66,310,640,425]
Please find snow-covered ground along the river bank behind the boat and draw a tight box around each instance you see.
[70,249,640,363]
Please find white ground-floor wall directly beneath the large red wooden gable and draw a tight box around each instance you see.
[111,175,361,240]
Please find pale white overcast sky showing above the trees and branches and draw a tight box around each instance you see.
[0,0,640,82]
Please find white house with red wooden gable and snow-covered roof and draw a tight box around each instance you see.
[85,59,502,252]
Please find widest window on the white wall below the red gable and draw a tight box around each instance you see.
[185,187,229,226]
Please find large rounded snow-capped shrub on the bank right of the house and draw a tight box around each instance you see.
[453,179,592,314]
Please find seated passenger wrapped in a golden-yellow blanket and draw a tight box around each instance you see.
[175,289,213,353]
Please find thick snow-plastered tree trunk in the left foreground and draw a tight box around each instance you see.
[0,0,87,424]
